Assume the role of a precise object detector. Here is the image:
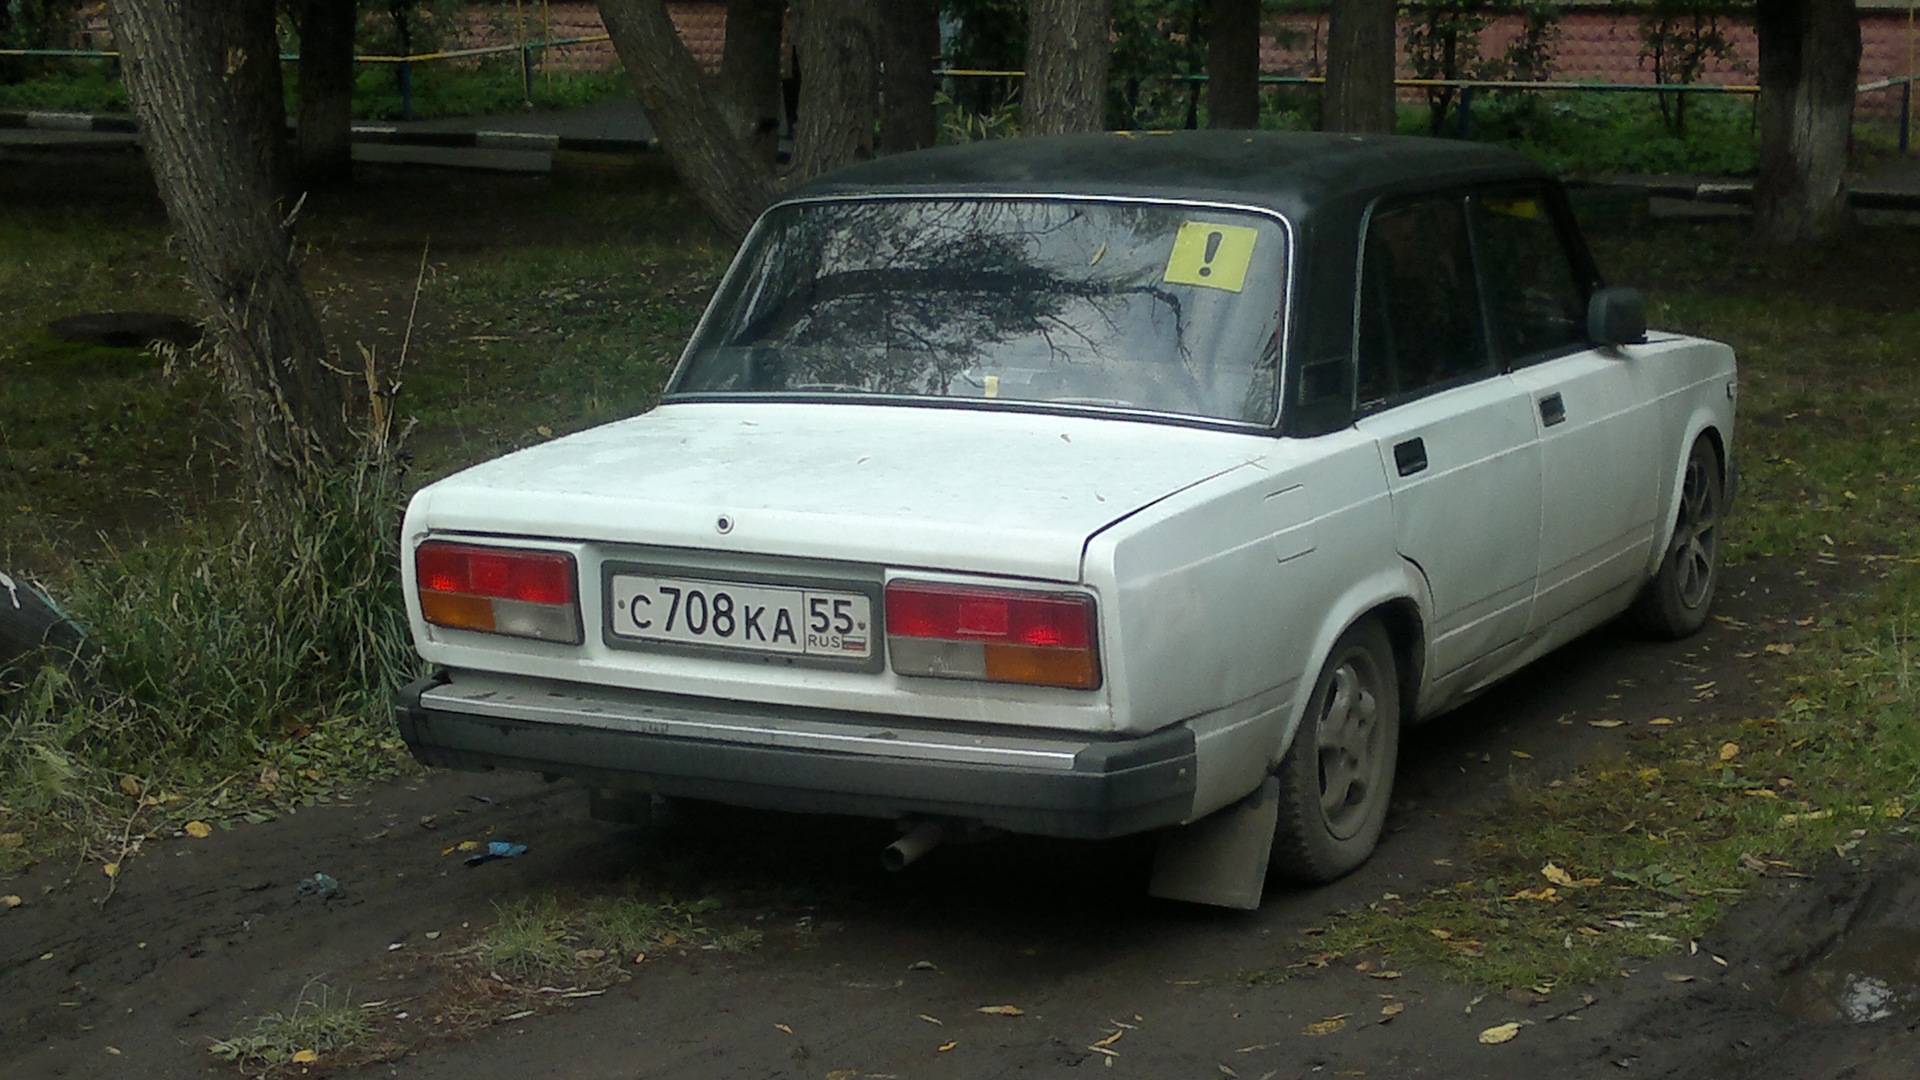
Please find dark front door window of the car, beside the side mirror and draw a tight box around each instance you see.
[1471,190,1588,367]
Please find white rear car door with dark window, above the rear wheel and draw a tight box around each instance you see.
[1356,196,1540,678]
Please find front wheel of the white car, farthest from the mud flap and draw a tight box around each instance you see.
[1632,438,1726,640]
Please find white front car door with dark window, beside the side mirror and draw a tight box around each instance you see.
[1469,186,1661,630]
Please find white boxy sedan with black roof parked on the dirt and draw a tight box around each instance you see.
[397,133,1736,907]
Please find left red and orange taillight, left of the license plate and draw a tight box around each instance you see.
[413,540,580,646]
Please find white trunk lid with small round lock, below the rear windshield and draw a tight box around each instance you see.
[411,402,1271,580]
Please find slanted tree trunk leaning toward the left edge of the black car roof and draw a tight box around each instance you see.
[599,0,776,240]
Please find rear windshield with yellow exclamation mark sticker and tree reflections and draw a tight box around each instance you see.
[668,198,1286,425]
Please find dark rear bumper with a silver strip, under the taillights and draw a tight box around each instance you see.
[394,675,1196,840]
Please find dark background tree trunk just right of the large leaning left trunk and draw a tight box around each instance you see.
[294,0,359,188]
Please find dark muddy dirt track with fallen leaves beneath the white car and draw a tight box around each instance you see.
[11,549,1920,1080]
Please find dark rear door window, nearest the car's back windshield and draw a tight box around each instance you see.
[1357,198,1492,409]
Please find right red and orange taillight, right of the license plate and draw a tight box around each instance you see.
[887,580,1100,690]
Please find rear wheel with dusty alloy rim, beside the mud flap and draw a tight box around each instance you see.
[1271,619,1400,884]
